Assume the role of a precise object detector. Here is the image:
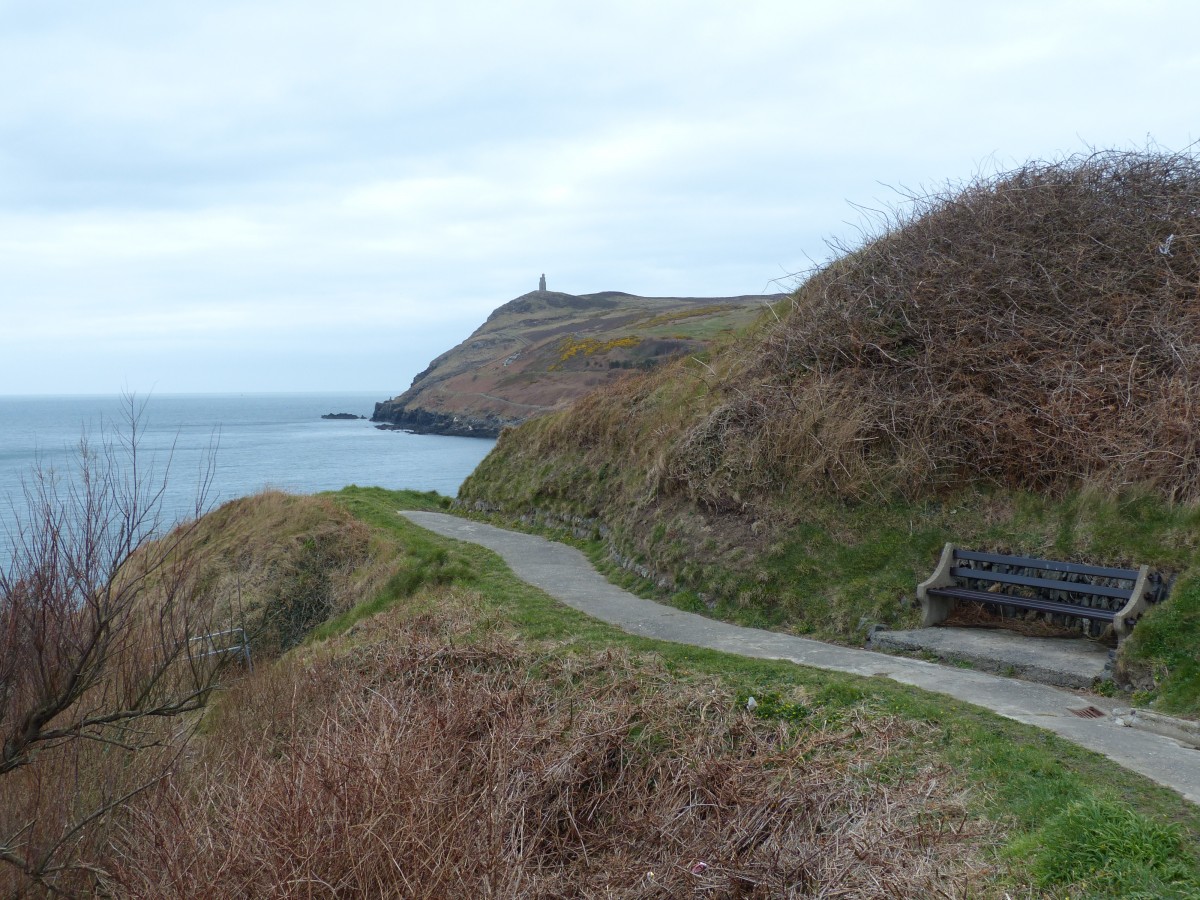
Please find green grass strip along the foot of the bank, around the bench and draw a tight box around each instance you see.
[464,451,1200,716]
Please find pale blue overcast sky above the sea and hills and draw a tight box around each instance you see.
[0,0,1200,400]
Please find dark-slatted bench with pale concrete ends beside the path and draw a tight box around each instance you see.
[917,544,1163,642]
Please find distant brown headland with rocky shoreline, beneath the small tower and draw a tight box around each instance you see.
[372,290,779,438]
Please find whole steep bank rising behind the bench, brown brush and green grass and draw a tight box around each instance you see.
[461,154,1200,713]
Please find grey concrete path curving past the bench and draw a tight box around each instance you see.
[401,511,1200,804]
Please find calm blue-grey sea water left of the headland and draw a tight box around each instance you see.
[0,392,494,530]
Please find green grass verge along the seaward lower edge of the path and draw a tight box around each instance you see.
[320,488,1200,898]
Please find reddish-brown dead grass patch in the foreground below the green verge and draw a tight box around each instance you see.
[109,589,995,900]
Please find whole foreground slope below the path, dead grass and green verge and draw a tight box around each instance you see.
[108,488,1200,898]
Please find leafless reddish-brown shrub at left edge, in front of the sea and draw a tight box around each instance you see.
[0,398,228,894]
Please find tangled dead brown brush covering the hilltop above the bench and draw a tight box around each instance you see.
[672,144,1200,506]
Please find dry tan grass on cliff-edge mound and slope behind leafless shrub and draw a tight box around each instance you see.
[0,492,403,896]
